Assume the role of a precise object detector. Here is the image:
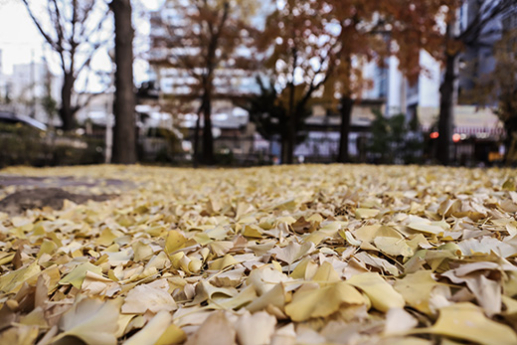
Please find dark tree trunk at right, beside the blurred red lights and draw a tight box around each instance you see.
[436,51,457,165]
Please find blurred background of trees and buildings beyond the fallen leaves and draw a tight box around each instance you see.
[0,0,517,167]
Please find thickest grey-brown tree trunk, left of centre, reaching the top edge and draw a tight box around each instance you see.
[110,0,136,164]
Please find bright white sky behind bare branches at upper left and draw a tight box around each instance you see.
[0,0,163,84]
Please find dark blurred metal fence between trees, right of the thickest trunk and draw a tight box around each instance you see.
[140,133,493,166]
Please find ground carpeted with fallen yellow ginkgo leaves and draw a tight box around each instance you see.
[0,165,517,345]
